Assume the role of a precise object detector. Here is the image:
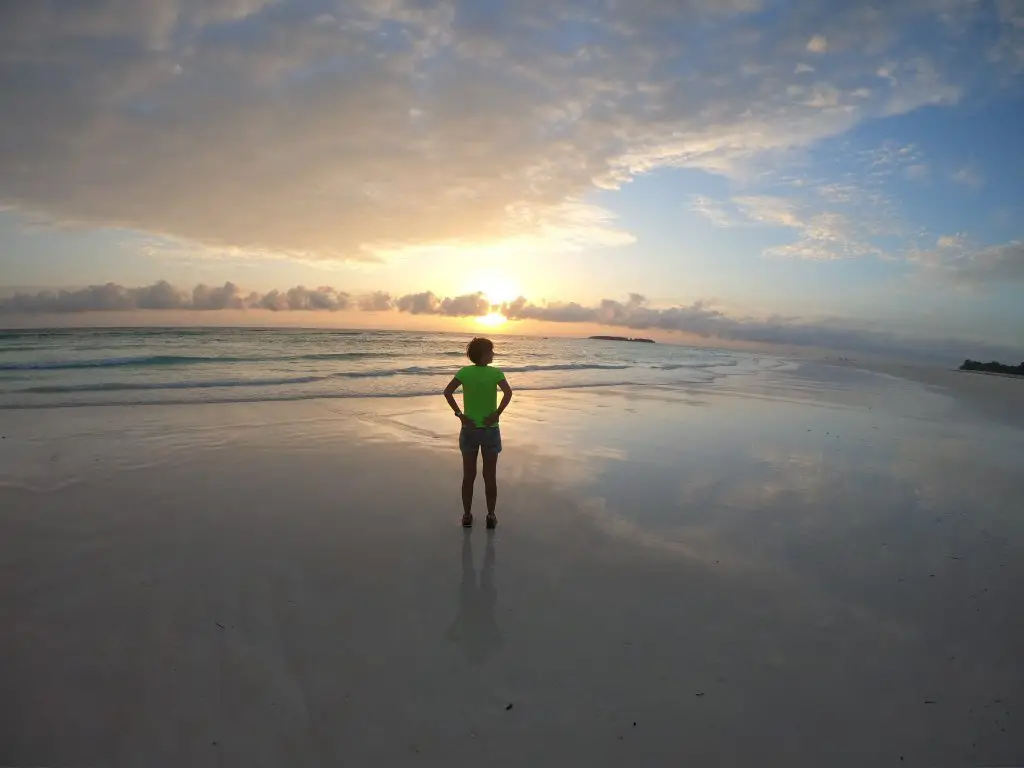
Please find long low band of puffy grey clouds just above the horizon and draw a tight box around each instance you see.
[0,280,1011,358]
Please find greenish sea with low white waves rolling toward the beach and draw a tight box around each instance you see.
[0,328,781,410]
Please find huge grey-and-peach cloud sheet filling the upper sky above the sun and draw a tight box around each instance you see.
[0,0,999,262]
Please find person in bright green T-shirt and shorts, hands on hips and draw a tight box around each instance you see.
[444,338,512,528]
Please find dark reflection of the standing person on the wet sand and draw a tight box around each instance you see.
[444,530,502,664]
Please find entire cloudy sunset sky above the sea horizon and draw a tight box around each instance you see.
[0,0,1024,358]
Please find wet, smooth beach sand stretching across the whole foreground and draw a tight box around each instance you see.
[0,364,1024,767]
